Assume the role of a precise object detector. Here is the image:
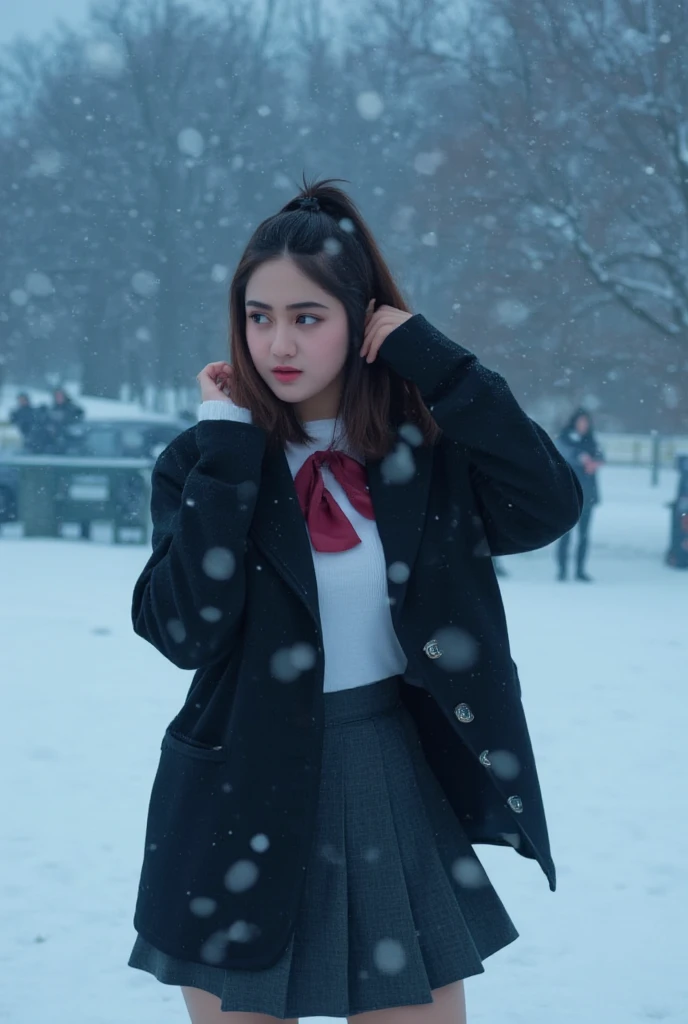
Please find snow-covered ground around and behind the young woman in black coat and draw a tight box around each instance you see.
[0,467,688,1024]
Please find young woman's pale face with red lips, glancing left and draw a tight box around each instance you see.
[246,257,349,422]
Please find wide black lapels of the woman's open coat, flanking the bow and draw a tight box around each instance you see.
[251,428,433,627]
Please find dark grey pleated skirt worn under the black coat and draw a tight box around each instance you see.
[128,677,518,1019]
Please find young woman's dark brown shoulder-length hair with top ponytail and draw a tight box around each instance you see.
[229,176,441,459]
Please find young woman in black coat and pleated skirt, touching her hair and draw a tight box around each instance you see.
[129,179,581,1024]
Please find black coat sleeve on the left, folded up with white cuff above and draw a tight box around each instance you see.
[132,420,266,669]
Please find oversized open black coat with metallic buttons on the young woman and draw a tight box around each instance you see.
[132,315,582,970]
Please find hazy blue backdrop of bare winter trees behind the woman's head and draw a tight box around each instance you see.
[0,0,688,433]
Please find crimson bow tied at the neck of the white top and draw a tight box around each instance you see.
[294,451,375,551]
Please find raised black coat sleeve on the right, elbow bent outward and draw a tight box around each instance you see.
[379,313,583,555]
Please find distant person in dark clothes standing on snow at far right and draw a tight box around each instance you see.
[556,409,604,583]
